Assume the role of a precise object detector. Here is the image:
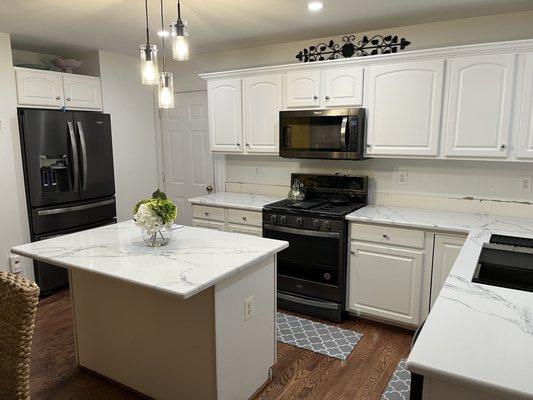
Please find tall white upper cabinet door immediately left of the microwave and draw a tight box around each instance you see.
[243,75,283,154]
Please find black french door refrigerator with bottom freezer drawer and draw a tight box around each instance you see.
[18,108,116,295]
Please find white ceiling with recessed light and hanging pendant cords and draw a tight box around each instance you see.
[0,0,533,55]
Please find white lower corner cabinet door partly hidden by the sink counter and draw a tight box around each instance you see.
[431,235,465,307]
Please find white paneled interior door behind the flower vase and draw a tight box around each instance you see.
[161,92,214,225]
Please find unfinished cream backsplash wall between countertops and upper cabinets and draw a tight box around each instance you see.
[225,155,533,217]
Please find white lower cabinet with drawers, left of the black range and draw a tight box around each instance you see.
[192,204,263,236]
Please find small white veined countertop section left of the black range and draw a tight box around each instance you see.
[189,192,283,211]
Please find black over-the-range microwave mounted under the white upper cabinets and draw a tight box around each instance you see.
[279,108,365,160]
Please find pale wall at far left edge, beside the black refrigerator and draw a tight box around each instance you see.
[0,33,33,279]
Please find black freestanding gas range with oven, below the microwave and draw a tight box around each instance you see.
[263,174,368,321]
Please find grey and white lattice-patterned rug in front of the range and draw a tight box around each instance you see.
[276,312,363,360]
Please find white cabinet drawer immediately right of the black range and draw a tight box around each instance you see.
[351,223,424,249]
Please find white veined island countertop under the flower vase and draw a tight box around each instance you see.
[11,221,288,298]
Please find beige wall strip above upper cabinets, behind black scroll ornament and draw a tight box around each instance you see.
[168,11,533,92]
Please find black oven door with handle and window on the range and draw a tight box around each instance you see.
[263,224,345,303]
